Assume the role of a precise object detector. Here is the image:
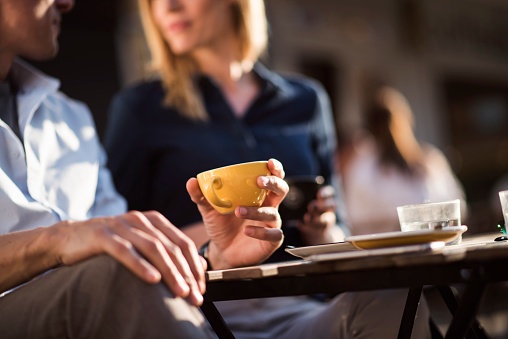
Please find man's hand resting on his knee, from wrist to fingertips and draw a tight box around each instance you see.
[48,211,206,306]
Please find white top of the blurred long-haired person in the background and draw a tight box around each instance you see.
[343,138,467,235]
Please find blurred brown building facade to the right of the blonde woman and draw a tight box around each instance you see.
[266,0,508,231]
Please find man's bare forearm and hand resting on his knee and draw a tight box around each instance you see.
[0,212,205,305]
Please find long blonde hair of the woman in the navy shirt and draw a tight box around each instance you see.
[138,0,268,121]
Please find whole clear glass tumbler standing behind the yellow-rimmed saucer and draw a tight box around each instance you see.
[397,201,462,243]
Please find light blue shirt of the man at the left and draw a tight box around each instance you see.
[0,60,126,234]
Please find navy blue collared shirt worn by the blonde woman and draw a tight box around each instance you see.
[104,63,348,259]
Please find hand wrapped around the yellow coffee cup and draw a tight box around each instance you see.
[187,159,288,269]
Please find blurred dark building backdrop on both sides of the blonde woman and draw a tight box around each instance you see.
[37,0,508,231]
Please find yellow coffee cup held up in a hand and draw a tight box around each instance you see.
[197,161,271,214]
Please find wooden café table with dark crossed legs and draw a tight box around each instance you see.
[201,233,508,338]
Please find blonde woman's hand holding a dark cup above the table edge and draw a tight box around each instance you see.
[296,186,344,245]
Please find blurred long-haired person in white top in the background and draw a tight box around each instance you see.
[340,87,467,234]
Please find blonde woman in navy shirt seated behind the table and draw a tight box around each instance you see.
[105,0,428,338]
